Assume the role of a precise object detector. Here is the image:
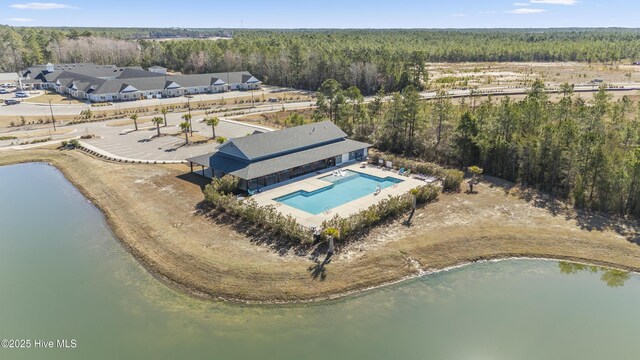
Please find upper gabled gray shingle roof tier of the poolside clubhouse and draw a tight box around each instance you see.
[218,121,347,160]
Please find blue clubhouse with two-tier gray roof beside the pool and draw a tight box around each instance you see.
[187,121,371,192]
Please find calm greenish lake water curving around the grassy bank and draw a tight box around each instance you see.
[0,164,640,360]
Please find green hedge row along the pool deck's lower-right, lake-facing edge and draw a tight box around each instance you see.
[322,185,439,241]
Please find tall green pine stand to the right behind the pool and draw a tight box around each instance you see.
[312,79,640,217]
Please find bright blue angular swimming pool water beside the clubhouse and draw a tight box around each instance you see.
[273,170,402,215]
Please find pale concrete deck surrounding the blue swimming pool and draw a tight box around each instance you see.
[251,163,426,227]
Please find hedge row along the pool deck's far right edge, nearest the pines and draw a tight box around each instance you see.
[369,149,464,192]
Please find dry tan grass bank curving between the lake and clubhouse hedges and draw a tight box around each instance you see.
[0,149,640,302]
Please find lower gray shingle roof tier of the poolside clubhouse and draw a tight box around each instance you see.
[210,140,371,180]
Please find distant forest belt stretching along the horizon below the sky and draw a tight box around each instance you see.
[0,26,640,94]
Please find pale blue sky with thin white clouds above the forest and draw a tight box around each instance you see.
[0,0,640,28]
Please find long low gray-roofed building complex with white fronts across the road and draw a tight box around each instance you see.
[19,63,262,102]
